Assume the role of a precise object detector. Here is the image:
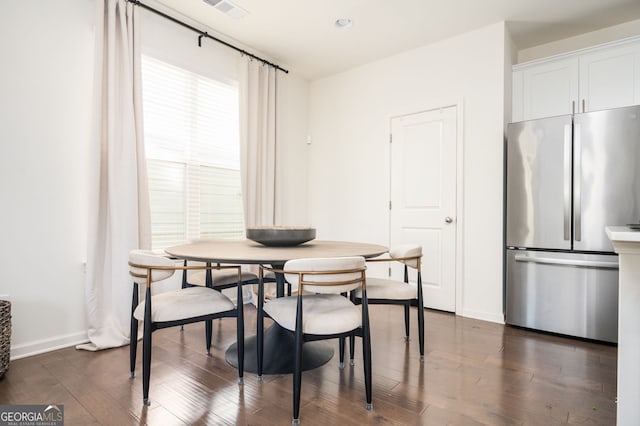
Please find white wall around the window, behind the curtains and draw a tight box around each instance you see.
[0,0,309,359]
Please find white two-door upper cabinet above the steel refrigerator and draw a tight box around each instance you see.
[511,39,640,122]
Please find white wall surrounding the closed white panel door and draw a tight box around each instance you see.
[309,23,508,322]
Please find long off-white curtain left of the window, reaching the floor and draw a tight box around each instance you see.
[78,0,151,350]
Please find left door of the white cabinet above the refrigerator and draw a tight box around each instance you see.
[522,58,579,120]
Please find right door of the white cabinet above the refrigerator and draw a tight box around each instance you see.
[576,43,640,112]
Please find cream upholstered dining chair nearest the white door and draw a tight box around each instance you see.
[339,244,424,366]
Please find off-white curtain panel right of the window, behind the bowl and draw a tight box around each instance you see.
[239,56,277,226]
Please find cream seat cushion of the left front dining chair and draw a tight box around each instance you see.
[133,287,235,322]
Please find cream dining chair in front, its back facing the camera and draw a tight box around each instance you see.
[258,257,372,425]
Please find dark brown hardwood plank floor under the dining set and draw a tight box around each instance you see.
[0,305,617,425]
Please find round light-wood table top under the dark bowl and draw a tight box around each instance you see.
[165,239,388,265]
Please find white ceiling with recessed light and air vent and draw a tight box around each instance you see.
[150,0,640,79]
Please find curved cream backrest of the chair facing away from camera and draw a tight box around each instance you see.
[284,256,367,293]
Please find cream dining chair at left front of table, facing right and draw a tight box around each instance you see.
[129,250,244,405]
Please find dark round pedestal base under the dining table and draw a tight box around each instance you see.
[225,324,333,374]
